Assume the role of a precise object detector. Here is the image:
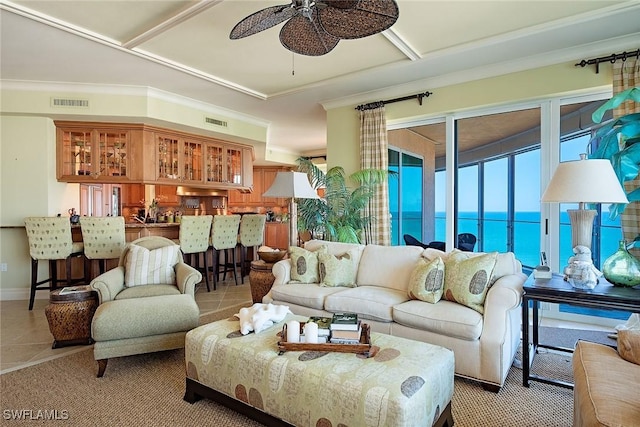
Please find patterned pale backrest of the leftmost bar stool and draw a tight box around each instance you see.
[24,217,83,260]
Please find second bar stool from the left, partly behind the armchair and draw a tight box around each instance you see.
[80,216,126,283]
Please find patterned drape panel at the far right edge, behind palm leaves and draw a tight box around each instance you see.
[613,58,640,258]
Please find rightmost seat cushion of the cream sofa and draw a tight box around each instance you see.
[393,300,483,341]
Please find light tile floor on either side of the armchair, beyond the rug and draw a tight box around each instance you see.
[0,277,251,374]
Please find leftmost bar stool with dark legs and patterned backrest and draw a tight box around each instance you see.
[24,217,85,310]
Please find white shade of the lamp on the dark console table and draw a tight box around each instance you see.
[542,159,629,203]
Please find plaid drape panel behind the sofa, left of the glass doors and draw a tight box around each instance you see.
[360,106,391,245]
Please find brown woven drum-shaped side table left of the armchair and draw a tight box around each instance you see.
[45,286,98,348]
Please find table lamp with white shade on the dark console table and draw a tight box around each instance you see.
[542,154,629,288]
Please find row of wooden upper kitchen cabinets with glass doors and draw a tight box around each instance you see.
[55,121,254,191]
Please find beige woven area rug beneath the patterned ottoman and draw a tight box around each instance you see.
[0,318,573,427]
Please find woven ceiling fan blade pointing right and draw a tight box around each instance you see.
[319,0,400,39]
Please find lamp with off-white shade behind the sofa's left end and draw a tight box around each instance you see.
[262,172,320,246]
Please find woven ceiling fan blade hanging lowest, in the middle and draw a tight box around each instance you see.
[280,8,340,56]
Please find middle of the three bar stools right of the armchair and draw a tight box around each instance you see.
[211,215,240,291]
